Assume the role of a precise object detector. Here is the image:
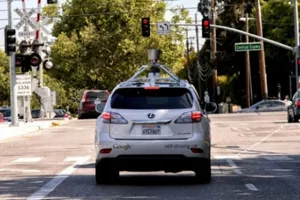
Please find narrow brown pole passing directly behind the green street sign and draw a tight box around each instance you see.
[245,12,251,107]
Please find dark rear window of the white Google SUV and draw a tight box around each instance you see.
[111,88,193,109]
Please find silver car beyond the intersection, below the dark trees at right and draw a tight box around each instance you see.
[234,100,289,113]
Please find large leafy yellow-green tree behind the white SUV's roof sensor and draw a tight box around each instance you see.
[51,0,188,89]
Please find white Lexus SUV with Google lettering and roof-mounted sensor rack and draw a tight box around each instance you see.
[95,62,216,184]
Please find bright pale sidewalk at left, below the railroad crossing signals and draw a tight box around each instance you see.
[0,120,67,141]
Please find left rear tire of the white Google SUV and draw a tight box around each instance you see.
[95,164,119,185]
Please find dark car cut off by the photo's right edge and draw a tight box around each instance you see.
[287,89,300,123]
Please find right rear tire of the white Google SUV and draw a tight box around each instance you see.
[194,158,211,184]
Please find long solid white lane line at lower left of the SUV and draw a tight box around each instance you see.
[26,156,90,200]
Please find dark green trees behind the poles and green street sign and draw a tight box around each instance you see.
[200,0,295,104]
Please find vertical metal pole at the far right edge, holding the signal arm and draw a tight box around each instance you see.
[294,0,300,91]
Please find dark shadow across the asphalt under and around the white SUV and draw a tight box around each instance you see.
[0,155,300,200]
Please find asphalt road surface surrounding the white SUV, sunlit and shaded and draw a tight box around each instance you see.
[0,113,300,200]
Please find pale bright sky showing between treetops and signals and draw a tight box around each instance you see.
[0,0,205,49]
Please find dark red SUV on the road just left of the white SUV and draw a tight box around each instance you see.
[78,90,109,119]
